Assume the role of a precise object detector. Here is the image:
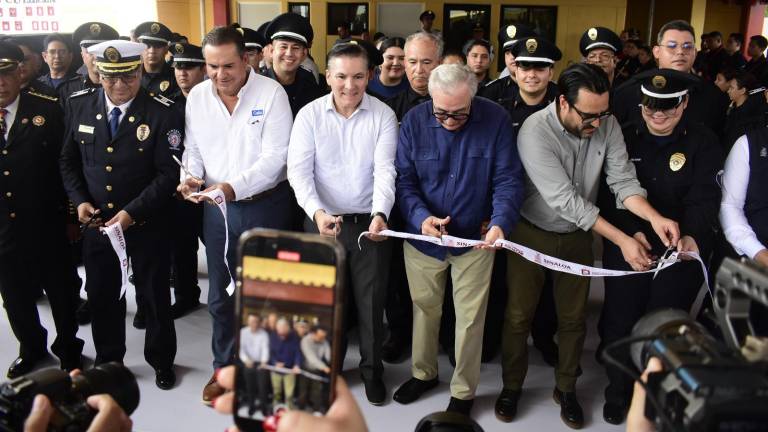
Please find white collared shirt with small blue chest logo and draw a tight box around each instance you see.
[180,68,293,200]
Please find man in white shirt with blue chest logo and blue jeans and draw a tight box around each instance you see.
[179,27,292,403]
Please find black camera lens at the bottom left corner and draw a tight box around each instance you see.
[72,362,139,415]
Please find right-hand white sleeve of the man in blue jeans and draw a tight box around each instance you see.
[227,86,293,199]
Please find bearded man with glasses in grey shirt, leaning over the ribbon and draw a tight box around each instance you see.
[496,63,680,429]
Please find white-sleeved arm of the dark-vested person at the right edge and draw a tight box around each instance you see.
[720,136,766,259]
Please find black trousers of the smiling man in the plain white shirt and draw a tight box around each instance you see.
[304,214,392,380]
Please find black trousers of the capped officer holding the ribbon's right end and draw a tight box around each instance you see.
[598,241,704,407]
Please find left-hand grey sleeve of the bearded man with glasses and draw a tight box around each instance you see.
[517,121,599,231]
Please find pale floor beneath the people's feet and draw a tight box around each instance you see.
[0,268,622,432]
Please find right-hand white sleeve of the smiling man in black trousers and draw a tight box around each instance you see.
[371,107,397,218]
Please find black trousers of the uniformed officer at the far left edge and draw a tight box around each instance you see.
[0,231,83,363]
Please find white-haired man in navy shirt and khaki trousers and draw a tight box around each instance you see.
[393,65,524,415]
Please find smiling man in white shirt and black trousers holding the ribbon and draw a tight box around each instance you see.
[288,43,397,405]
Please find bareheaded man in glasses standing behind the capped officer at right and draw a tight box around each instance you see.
[611,20,728,135]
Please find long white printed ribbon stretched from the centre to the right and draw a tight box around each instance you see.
[357,230,709,290]
